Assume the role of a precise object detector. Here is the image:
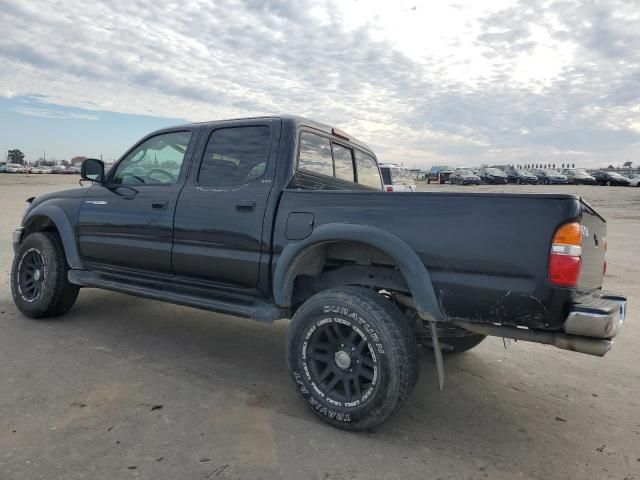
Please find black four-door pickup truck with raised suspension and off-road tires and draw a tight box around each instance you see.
[11,117,625,430]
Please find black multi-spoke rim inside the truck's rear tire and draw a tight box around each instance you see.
[302,319,378,407]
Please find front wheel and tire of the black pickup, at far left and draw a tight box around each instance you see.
[11,232,79,318]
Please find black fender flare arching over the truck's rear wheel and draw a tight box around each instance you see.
[273,223,445,321]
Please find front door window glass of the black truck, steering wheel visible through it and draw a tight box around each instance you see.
[112,132,191,185]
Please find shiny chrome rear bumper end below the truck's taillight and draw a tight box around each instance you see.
[563,293,627,339]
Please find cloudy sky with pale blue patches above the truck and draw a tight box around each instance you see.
[0,0,640,166]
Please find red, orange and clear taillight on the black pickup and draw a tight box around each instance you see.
[549,222,582,287]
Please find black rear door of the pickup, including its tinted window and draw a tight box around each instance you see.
[173,119,280,288]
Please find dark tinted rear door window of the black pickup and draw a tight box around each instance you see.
[198,126,271,187]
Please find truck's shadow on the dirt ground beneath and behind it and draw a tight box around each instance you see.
[57,291,604,468]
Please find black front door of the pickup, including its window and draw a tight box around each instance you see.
[78,129,196,275]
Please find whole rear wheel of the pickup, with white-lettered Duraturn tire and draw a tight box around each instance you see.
[287,287,419,430]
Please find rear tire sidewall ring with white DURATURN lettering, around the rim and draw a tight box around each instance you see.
[287,298,396,428]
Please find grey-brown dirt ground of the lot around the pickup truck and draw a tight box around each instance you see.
[0,174,640,480]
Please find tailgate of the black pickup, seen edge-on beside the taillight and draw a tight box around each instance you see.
[578,199,607,291]
